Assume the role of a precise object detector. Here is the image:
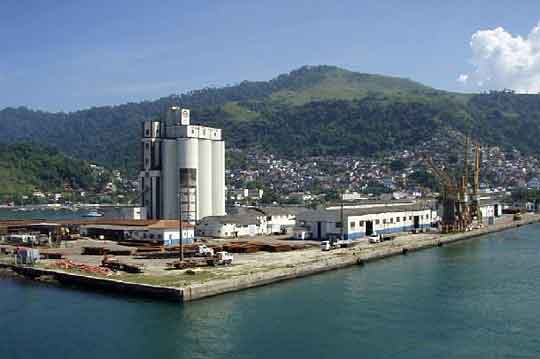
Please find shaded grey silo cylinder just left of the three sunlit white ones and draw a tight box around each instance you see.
[161,139,178,219]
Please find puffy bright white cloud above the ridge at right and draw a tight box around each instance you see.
[457,24,540,93]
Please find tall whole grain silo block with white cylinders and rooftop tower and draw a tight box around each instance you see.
[139,107,225,223]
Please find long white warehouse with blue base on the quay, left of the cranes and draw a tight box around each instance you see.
[295,204,436,240]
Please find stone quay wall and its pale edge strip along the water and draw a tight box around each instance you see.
[0,214,540,302]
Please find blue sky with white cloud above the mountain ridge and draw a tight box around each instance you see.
[0,0,540,112]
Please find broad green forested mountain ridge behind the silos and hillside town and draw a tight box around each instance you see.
[0,66,540,174]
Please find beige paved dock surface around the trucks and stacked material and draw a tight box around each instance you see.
[2,214,540,301]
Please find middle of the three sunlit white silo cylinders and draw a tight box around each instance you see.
[198,138,214,218]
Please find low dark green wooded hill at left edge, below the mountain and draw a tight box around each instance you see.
[0,144,96,199]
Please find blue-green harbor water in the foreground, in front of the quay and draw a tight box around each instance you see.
[0,225,540,359]
